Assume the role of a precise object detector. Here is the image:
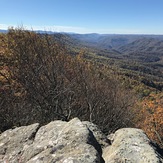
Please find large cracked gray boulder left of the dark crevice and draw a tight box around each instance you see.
[0,118,103,163]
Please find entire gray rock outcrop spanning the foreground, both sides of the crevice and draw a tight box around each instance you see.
[0,118,163,163]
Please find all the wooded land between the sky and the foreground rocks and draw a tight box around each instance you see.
[0,29,163,145]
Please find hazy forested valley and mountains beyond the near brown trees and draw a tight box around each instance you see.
[70,34,163,90]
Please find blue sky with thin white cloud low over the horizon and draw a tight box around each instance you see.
[0,0,163,34]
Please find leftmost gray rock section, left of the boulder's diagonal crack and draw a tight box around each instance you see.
[0,123,39,163]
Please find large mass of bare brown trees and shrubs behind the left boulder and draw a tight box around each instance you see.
[0,29,134,132]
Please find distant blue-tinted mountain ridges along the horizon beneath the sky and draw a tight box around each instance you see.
[0,30,163,53]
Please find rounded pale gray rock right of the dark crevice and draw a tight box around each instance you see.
[103,128,163,163]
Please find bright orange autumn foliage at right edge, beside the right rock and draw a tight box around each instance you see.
[137,93,163,146]
